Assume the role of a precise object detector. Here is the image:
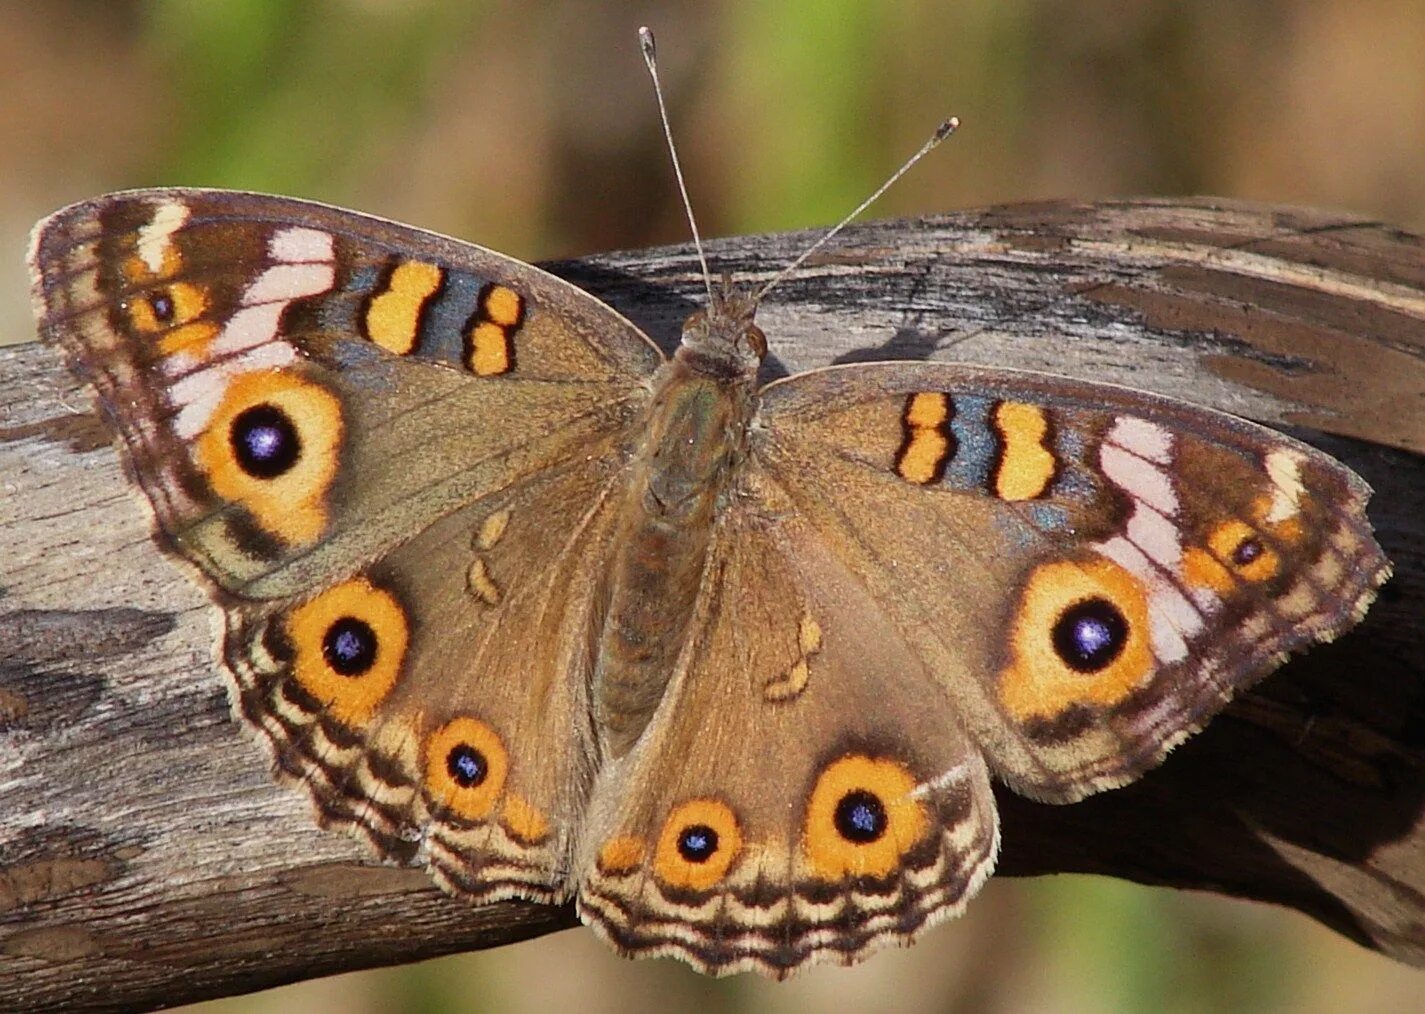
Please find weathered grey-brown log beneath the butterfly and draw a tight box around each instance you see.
[0,201,1425,1010]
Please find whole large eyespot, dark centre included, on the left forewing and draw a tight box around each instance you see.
[195,370,345,545]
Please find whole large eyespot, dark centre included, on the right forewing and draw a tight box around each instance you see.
[999,558,1154,722]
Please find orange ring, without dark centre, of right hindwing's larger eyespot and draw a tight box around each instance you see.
[802,753,931,882]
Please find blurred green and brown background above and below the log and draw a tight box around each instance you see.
[0,0,1425,1014]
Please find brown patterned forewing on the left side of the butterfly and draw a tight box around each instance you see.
[30,189,661,598]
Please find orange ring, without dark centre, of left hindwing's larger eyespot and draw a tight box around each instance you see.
[285,577,410,726]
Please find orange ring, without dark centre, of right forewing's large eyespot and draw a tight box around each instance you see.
[999,558,1154,722]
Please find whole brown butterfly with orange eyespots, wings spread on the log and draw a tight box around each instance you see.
[30,189,1389,977]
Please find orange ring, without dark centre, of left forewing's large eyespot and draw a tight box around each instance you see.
[195,370,345,545]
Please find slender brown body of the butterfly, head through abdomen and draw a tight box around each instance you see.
[596,292,767,756]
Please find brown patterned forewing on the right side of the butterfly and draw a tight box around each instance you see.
[752,363,1389,802]
